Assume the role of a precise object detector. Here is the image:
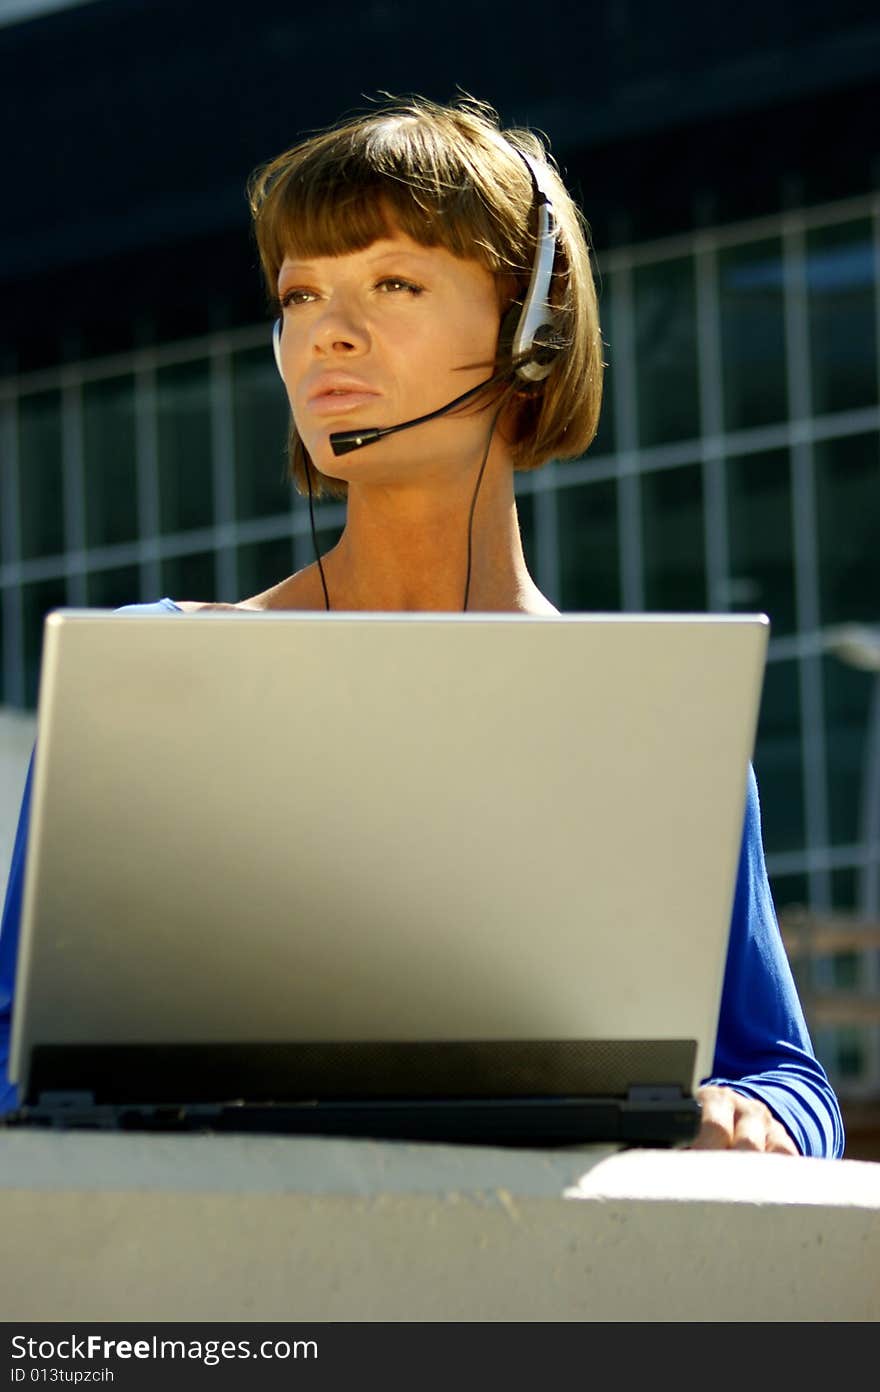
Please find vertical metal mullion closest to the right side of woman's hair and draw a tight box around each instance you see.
[611,266,645,612]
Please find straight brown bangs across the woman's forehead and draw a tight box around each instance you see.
[249,116,532,299]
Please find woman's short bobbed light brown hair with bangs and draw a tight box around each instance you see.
[248,97,603,497]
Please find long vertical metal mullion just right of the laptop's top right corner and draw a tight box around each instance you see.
[783,223,831,918]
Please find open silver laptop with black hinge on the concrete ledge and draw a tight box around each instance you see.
[7,610,769,1146]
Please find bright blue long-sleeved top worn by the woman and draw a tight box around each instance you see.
[0,599,844,1157]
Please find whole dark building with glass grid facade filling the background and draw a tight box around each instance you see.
[0,0,880,1130]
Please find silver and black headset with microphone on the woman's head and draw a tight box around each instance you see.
[272,136,565,437]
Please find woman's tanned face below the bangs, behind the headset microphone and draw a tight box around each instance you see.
[278,230,501,483]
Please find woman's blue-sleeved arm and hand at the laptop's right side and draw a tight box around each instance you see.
[698,768,844,1157]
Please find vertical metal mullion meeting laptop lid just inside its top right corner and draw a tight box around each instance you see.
[693,237,730,612]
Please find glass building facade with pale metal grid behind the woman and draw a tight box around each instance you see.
[0,187,880,1097]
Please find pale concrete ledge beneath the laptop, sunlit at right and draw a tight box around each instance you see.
[0,1132,880,1321]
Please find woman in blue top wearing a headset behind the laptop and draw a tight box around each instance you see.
[0,89,842,1155]
